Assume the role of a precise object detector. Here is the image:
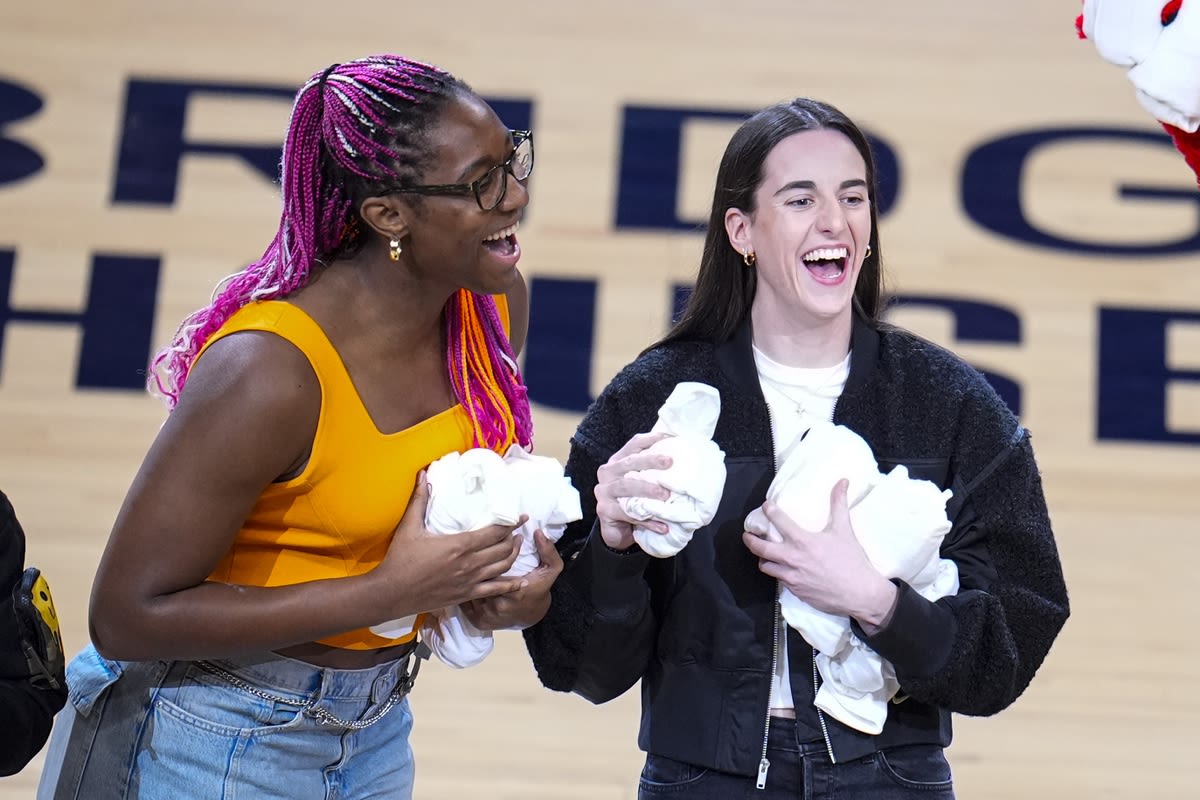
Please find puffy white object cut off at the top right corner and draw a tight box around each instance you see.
[1084,0,1200,133]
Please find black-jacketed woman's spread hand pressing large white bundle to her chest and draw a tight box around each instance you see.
[742,480,896,632]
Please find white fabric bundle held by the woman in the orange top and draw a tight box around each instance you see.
[371,445,583,668]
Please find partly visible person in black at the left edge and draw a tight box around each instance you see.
[0,492,67,776]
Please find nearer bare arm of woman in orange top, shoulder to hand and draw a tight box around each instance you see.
[90,333,520,658]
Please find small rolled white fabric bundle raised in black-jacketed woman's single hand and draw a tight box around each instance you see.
[620,381,725,558]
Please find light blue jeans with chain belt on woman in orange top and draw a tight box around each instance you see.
[37,645,415,800]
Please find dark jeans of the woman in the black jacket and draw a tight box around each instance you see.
[637,717,954,800]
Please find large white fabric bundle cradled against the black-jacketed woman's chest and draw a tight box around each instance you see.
[745,422,959,734]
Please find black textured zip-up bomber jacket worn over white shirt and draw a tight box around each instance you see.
[524,319,1068,775]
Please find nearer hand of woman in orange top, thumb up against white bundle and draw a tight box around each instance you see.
[371,470,526,622]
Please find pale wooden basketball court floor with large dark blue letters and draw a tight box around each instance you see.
[0,0,1200,800]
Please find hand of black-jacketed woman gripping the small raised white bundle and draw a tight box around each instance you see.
[595,433,671,551]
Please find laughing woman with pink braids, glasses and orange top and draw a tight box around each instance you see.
[38,55,562,799]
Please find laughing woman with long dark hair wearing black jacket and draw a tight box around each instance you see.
[526,98,1068,800]
